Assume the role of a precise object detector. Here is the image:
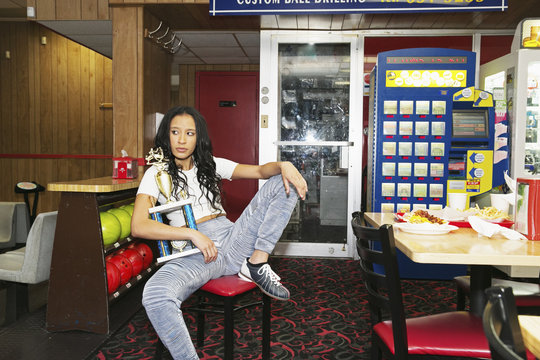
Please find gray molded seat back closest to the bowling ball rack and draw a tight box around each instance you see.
[19,211,57,284]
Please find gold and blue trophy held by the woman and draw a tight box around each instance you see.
[145,148,199,263]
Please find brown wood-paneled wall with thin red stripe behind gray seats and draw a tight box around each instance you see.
[0,22,113,212]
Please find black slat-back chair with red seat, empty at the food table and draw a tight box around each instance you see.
[352,212,490,359]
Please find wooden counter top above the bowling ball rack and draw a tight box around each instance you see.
[47,176,141,193]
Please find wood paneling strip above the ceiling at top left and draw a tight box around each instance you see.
[27,0,111,20]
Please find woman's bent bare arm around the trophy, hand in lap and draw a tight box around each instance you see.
[131,194,217,262]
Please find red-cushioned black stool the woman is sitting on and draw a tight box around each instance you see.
[156,275,271,360]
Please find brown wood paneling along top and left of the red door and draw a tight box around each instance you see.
[177,64,259,106]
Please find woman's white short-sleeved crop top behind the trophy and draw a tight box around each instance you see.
[137,157,238,227]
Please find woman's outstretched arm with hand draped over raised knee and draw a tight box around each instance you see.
[232,161,307,200]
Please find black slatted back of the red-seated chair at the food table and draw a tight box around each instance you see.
[352,212,408,359]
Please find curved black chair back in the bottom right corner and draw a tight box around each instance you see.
[482,286,527,360]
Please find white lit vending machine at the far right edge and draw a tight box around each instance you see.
[480,19,540,179]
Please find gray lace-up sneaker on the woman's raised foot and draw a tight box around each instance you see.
[238,259,291,300]
